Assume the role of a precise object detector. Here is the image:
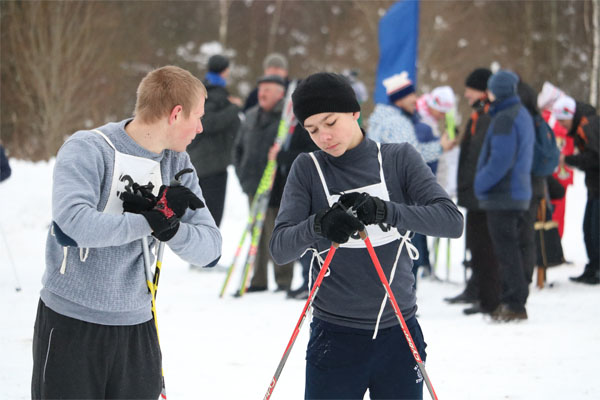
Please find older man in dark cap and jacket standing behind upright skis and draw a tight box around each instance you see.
[233,75,316,292]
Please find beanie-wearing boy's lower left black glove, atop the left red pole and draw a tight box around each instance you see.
[314,204,365,244]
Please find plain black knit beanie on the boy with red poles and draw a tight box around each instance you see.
[292,72,360,125]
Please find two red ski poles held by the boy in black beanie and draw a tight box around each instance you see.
[263,230,437,400]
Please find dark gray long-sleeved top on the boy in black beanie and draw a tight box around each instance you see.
[270,138,463,329]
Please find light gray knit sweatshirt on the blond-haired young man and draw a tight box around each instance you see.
[41,119,221,325]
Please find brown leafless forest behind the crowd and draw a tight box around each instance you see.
[0,0,600,161]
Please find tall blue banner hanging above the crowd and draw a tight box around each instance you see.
[375,0,419,104]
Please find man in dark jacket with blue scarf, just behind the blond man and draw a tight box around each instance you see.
[187,55,241,226]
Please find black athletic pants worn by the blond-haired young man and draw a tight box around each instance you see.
[31,300,162,400]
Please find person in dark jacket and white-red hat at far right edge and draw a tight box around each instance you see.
[552,96,600,285]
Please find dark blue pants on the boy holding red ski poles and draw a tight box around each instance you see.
[304,317,427,400]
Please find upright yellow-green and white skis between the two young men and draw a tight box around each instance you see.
[219,81,297,297]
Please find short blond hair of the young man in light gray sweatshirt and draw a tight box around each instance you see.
[134,65,207,124]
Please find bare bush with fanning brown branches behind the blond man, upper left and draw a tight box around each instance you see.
[2,1,112,159]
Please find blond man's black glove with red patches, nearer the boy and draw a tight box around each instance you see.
[140,185,204,242]
